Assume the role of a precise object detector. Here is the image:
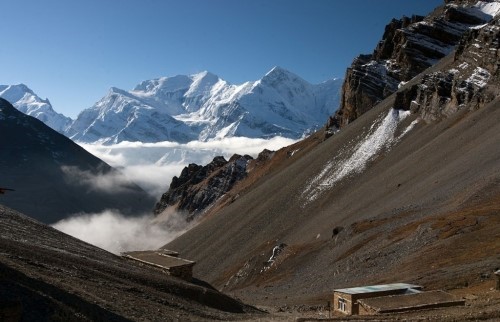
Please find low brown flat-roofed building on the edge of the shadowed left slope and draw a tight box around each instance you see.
[121,249,195,281]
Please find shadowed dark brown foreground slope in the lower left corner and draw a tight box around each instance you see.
[0,206,264,321]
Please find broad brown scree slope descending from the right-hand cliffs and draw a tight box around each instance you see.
[169,54,500,302]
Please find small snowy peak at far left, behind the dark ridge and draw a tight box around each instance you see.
[0,84,73,133]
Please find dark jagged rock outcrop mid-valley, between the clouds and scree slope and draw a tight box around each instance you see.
[154,154,253,221]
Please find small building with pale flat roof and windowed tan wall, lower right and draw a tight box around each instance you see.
[332,283,422,315]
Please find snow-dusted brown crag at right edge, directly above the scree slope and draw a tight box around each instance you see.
[395,15,500,121]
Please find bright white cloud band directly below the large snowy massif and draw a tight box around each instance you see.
[80,137,296,198]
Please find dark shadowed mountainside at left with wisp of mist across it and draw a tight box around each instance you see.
[0,99,154,223]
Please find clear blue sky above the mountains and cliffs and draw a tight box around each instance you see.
[0,0,443,118]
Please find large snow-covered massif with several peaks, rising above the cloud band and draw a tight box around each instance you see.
[66,67,342,143]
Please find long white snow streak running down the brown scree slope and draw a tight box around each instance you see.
[303,109,416,204]
